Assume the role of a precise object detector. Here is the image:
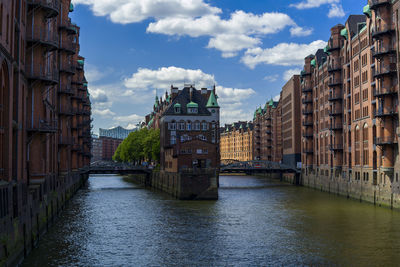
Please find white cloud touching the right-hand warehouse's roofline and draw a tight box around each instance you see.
[241,40,327,69]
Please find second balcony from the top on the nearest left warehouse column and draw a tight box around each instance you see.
[26,28,58,51]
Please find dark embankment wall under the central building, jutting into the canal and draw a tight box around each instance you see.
[132,170,218,200]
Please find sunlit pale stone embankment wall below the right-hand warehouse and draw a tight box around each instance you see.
[301,173,400,209]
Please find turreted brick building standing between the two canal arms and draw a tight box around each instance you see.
[146,85,220,172]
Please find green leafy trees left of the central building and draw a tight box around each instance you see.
[113,128,160,164]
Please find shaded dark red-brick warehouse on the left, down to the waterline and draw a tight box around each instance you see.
[0,0,91,265]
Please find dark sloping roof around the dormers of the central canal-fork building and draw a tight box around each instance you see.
[163,87,211,116]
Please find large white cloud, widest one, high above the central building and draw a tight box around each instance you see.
[147,10,312,57]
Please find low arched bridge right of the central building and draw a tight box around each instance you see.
[220,160,300,174]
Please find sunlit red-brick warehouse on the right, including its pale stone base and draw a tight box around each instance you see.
[301,0,400,207]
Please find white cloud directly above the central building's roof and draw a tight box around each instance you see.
[124,66,215,93]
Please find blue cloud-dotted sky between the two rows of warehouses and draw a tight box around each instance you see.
[71,0,367,133]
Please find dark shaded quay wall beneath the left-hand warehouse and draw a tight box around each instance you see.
[0,171,89,266]
